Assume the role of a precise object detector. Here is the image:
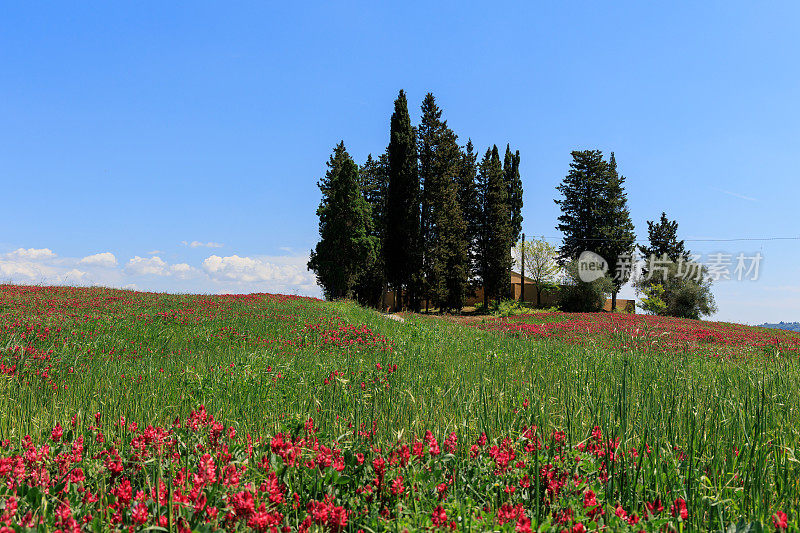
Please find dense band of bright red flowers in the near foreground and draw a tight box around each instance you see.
[0,406,708,532]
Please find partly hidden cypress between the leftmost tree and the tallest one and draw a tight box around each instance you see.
[355,153,389,307]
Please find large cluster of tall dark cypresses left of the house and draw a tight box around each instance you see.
[308,90,522,311]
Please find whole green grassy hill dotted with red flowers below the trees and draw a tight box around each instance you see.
[0,285,800,531]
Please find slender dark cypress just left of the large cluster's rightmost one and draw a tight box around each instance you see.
[478,146,513,307]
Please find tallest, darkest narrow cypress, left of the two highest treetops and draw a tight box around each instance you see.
[384,90,422,310]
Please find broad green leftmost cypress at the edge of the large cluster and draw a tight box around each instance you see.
[308,142,376,299]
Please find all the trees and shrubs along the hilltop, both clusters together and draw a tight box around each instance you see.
[308,90,716,318]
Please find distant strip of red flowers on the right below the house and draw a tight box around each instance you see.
[481,312,800,357]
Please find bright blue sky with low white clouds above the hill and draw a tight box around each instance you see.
[0,1,800,323]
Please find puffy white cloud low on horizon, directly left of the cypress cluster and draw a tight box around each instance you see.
[203,255,309,285]
